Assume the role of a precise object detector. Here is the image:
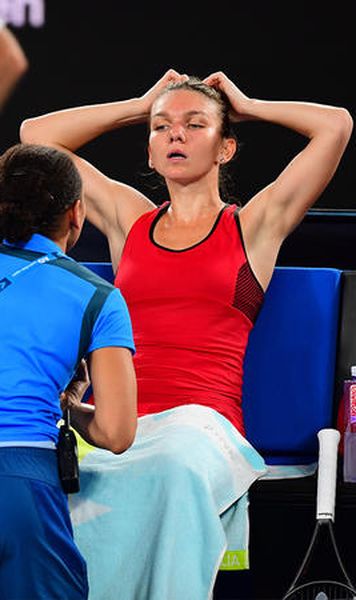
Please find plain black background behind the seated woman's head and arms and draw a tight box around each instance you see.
[0,0,356,260]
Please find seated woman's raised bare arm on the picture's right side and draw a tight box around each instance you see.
[205,73,353,285]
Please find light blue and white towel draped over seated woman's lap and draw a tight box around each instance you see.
[70,405,266,600]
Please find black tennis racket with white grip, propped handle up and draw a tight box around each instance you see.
[283,429,356,600]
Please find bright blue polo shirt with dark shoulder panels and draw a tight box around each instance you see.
[0,234,135,445]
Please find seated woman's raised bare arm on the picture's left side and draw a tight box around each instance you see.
[20,69,186,269]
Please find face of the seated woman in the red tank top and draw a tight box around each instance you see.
[149,89,223,184]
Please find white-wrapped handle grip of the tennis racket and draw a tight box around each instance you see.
[316,428,340,521]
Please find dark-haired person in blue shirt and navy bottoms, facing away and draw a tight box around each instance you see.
[0,144,137,600]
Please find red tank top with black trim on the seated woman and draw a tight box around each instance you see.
[115,202,264,433]
